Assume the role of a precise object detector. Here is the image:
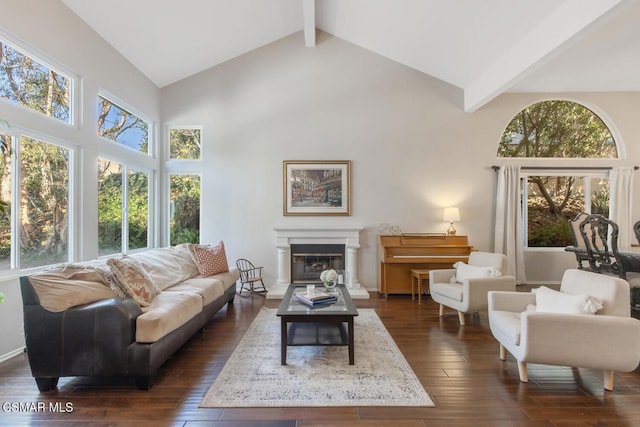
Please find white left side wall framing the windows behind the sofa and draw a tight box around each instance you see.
[0,0,160,360]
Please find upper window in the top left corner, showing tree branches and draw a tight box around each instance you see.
[0,39,73,123]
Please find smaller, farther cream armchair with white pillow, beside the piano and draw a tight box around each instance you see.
[429,252,516,326]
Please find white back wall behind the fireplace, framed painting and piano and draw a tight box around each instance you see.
[162,29,640,289]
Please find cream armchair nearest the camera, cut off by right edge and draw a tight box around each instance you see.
[488,269,640,390]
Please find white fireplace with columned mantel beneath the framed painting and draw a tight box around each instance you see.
[267,226,369,299]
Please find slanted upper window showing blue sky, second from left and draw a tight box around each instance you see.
[97,96,150,154]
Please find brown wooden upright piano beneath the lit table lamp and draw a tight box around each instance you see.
[378,233,474,296]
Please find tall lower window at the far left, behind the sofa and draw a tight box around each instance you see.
[0,134,73,270]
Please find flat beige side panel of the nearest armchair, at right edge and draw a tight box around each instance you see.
[520,312,640,372]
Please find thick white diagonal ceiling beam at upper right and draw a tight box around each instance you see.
[464,0,625,112]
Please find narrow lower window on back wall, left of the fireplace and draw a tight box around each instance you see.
[169,175,200,245]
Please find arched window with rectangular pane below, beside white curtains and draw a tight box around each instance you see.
[498,100,618,247]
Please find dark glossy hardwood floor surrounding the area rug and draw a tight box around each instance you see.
[0,294,640,427]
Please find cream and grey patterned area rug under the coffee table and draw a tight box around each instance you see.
[200,308,434,408]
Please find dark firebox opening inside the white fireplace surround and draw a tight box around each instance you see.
[291,244,344,283]
